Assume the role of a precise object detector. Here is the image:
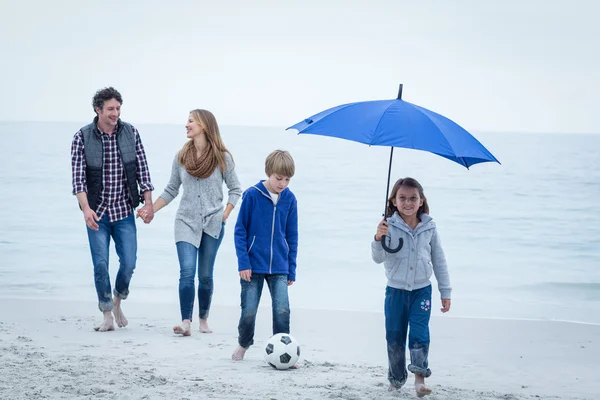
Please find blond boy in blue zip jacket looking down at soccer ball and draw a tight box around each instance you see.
[231,150,298,361]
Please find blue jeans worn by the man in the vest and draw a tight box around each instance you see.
[87,213,137,312]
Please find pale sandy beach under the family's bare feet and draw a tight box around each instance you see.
[0,295,600,400]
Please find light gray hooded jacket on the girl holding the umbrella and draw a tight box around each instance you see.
[371,212,452,299]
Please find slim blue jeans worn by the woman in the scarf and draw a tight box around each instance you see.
[176,225,225,321]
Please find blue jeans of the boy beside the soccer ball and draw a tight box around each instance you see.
[238,274,290,349]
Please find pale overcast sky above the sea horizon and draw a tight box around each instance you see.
[0,0,600,133]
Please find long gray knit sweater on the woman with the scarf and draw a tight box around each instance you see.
[160,152,242,247]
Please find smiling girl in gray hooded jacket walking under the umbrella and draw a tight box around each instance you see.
[371,178,452,397]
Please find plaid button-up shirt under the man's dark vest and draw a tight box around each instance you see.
[71,122,154,222]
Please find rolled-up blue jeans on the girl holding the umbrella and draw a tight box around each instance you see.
[384,285,431,387]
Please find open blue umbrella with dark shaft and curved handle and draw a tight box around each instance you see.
[287,84,500,252]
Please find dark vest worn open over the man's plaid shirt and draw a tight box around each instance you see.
[81,117,141,211]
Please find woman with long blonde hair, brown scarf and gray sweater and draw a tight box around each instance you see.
[140,110,242,336]
